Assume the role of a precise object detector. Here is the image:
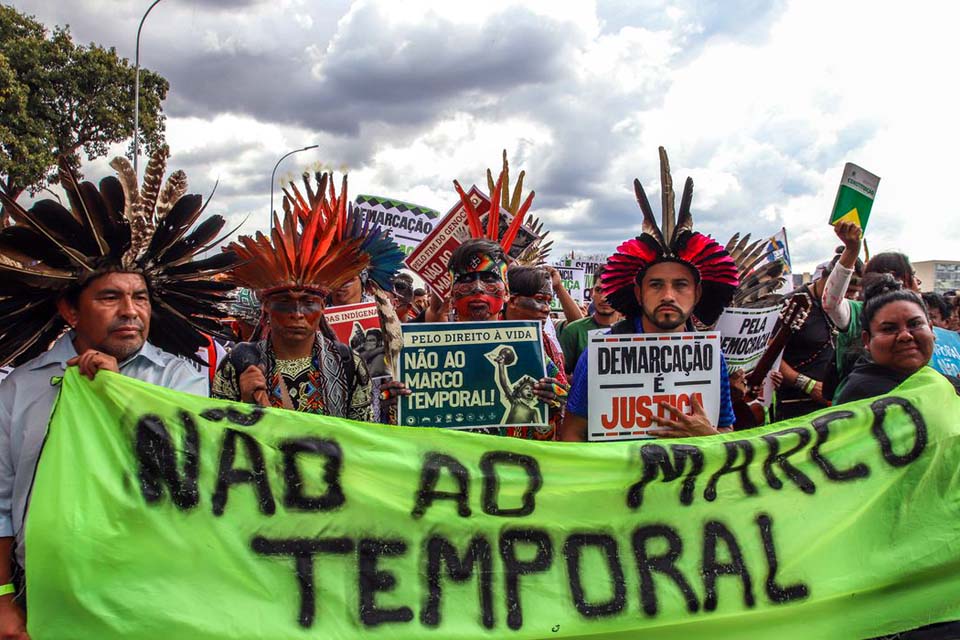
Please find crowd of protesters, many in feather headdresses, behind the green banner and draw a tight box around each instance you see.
[0,150,960,637]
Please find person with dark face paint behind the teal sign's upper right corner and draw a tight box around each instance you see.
[503,265,569,440]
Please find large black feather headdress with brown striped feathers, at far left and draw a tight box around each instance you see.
[0,146,236,364]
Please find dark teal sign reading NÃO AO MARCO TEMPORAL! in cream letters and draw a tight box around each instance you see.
[398,320,547,429]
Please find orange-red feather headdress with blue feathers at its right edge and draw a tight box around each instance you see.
[229,173,403,300]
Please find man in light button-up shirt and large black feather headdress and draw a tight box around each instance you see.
[0,148,237,640]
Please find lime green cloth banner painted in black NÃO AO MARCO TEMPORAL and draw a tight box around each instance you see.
[26,368,960,640]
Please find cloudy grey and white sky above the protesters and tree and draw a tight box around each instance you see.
[13,0,960,270]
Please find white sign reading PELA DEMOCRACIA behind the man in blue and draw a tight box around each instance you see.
[715,307,780,407]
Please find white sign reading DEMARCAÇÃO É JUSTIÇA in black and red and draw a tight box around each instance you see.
[587,331,720,442]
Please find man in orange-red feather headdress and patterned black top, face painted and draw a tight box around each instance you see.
[213,174,403,421]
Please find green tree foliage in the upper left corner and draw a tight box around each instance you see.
[0,5,170,226]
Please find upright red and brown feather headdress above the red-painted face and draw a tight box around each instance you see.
[453,150,553,266]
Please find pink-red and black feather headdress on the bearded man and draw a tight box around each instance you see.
[601,147,738,325]
